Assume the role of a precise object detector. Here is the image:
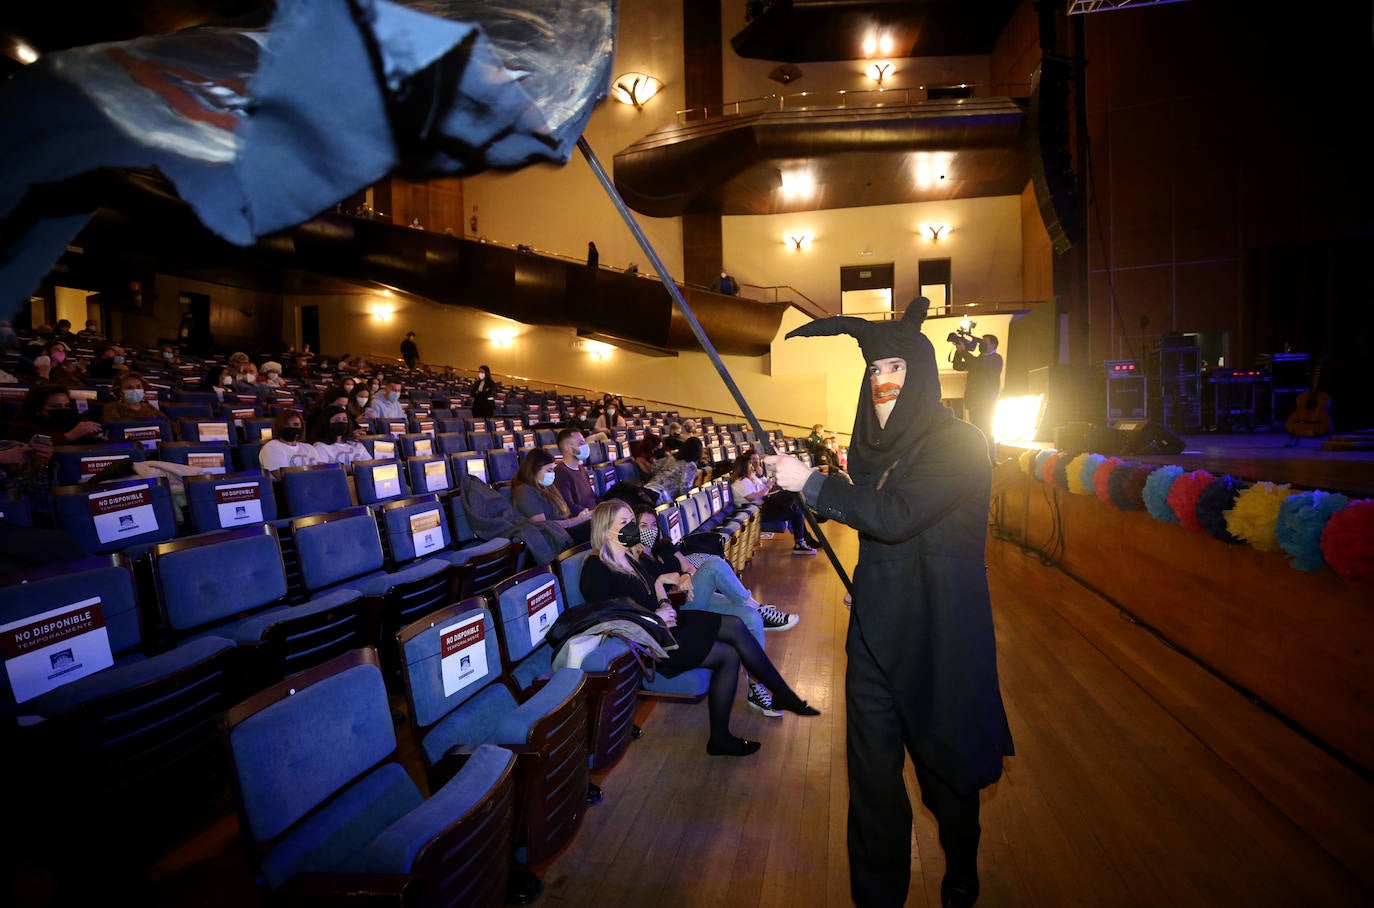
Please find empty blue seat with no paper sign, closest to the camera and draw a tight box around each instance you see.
[224,648,515,908]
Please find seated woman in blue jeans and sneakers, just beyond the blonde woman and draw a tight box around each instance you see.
[635,507,801,717]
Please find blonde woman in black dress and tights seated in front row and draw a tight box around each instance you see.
[581,500,820,757]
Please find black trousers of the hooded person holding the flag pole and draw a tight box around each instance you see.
[845,618,981,908]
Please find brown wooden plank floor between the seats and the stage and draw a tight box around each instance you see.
[13,522,1374,908]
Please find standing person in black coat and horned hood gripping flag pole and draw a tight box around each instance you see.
[767,297,1013,908]
